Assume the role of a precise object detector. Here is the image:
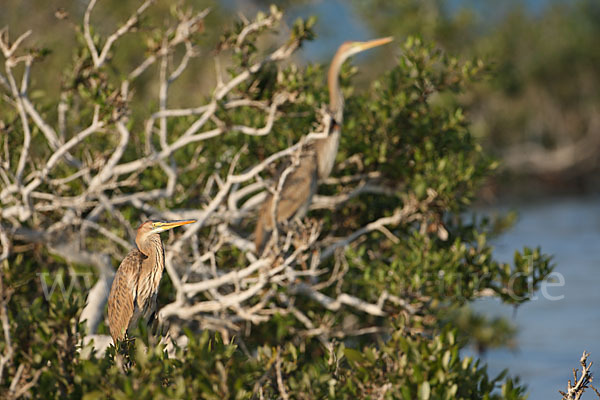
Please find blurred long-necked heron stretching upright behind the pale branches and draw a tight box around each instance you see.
[254,37,392,254]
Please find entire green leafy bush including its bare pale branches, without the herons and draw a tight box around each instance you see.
[0,1,552,399]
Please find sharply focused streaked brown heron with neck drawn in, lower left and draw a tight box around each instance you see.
[108,219,196,344]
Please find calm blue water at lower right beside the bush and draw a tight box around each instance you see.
[464,197,600,400]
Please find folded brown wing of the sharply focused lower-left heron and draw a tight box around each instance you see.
[108,249,143,343]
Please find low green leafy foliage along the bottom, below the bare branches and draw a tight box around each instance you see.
[5,282,524,400]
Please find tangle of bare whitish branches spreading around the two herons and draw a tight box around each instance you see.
[0,0,426,346]
